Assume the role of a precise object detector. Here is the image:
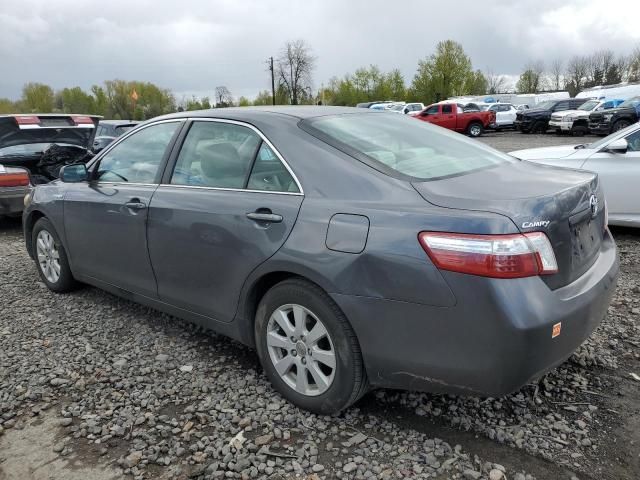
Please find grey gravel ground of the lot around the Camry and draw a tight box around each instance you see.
[0,133,640,480]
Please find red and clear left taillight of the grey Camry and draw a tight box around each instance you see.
[418,232,558,278]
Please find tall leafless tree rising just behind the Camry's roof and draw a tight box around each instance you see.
[277,40,316,105]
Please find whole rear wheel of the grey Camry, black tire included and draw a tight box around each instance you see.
[254,279,368,415]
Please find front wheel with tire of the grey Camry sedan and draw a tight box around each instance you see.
[31,217,78,293]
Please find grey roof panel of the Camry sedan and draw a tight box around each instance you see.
[153,105,375,120]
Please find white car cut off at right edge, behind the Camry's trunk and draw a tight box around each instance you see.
[510,119,640,227]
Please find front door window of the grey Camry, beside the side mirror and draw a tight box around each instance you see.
[95,122,181,183]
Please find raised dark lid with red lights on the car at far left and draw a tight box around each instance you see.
[0,115,100,149]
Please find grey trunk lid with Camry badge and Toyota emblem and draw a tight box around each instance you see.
[413,162,605,289]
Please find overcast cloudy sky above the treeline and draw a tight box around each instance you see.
[0,0,640,99]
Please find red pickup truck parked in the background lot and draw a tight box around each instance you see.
[413,103,496,137]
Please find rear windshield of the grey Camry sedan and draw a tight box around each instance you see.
[300,113,516,181]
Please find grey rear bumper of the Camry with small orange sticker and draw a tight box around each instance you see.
[332,232,618,397]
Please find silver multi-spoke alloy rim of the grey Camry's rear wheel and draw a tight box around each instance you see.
[266,304,336,396]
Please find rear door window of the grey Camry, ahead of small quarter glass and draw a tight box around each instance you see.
[171,121,262,189]
